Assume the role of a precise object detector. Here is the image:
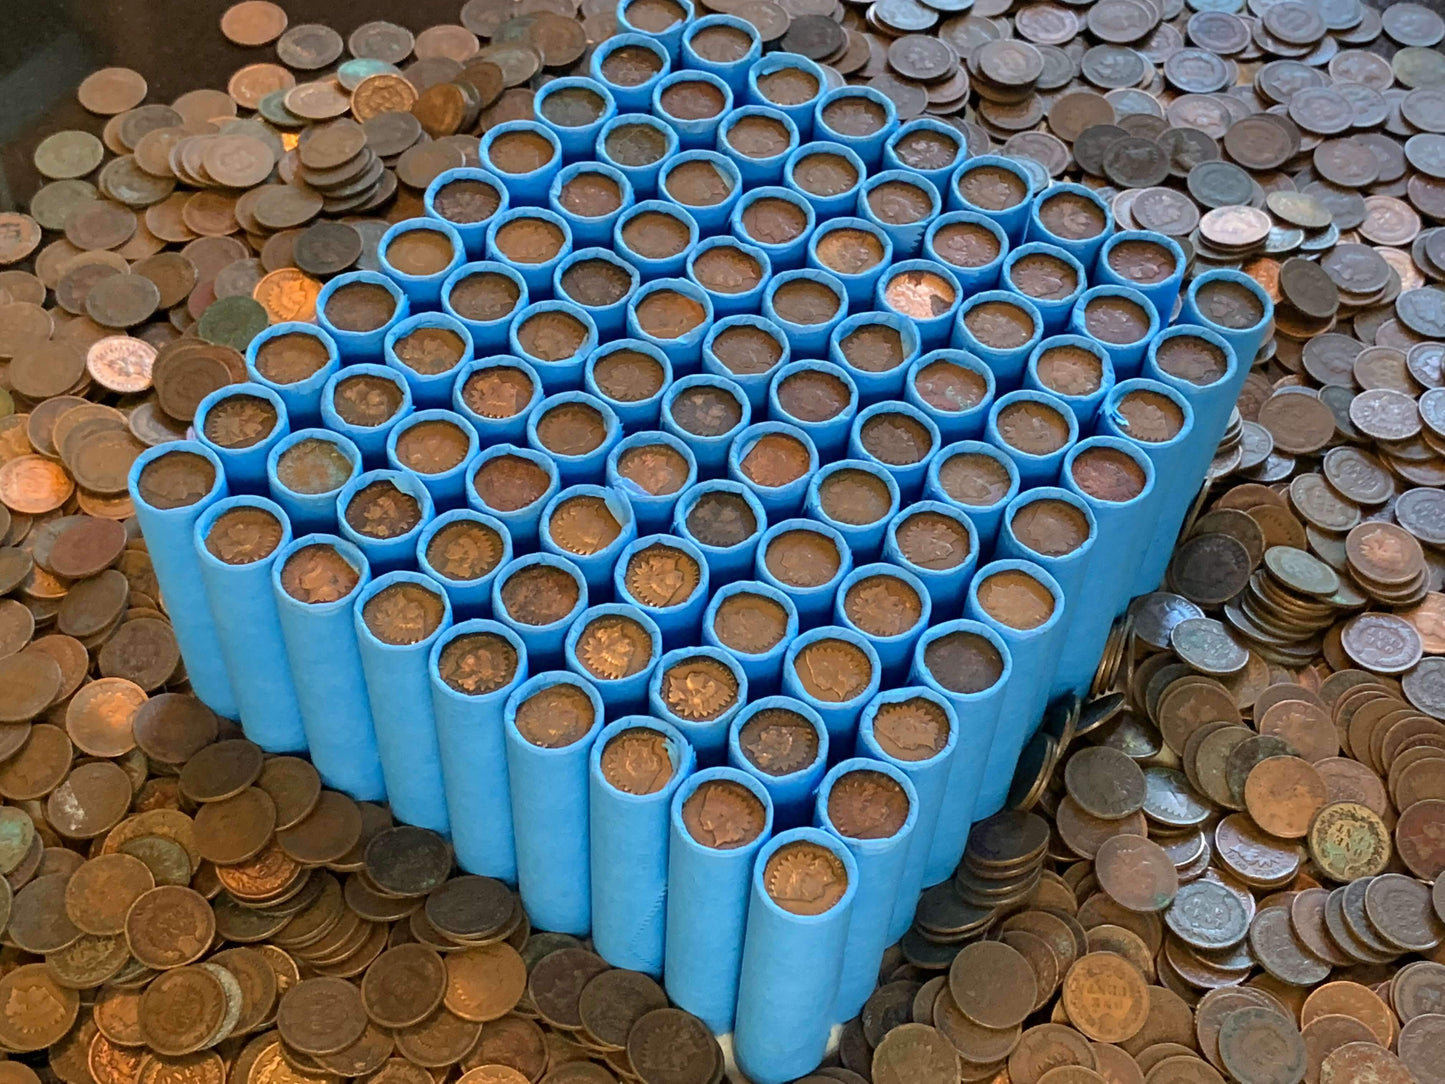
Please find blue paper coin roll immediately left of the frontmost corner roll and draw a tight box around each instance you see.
[662,767,773,1035]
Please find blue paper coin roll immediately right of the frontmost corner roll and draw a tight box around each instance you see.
[814,757,918,1020]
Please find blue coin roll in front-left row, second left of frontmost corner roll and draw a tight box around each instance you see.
[588,715,695,976]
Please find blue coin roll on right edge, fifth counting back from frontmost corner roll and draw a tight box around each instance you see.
[964,560,1066,821]
